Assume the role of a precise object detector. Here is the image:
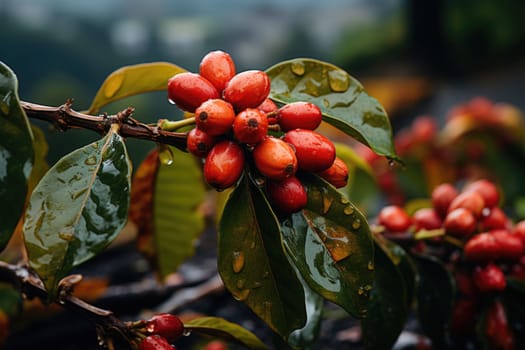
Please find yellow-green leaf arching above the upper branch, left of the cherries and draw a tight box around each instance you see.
[87,62,186,114]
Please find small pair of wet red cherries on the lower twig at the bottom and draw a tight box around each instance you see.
[138,313,184,350]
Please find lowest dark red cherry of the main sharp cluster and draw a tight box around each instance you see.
[266,176,308,215]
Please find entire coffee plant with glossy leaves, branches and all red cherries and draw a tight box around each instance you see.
[0,51,525,350]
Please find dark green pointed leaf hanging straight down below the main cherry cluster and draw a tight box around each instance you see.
[218,176,306,339]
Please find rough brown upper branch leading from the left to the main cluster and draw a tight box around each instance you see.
[20,100,186,150]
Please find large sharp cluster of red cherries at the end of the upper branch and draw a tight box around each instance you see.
[168,51,348,214]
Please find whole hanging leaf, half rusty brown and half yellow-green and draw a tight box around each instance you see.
[129,148,206,278]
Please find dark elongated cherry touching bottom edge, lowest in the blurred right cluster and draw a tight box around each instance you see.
[485,299,516,350]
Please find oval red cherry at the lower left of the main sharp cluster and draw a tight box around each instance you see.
[203,140,245,190]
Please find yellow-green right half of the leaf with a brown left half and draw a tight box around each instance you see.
[153,148,206,277]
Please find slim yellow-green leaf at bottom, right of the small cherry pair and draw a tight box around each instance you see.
[184,317,268,350]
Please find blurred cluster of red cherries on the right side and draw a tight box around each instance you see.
[378,179,525,349]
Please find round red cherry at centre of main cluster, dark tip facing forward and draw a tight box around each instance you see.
[233,108,268,145]
